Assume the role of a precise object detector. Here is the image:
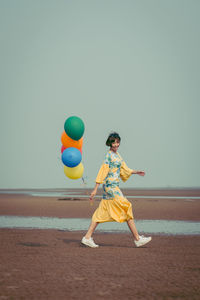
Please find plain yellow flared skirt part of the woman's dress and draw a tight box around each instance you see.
[92,196,133,223]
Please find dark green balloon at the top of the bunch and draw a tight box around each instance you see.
[64,116,85,141]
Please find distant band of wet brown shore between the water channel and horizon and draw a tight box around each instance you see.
[0,189,200,221]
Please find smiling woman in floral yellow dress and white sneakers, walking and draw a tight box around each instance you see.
[81,132,151,248]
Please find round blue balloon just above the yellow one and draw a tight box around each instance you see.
[62,147,82,168]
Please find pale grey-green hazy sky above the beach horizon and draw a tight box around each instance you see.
[0,0,200,189]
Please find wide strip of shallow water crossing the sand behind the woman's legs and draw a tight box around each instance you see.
[0,216,200,235]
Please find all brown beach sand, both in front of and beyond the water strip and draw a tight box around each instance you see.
[0,191,200,300]
